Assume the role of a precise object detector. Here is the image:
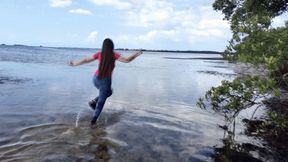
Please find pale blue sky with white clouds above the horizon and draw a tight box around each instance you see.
[0,0,284,51]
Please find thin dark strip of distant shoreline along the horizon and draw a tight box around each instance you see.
[0,44,223,54]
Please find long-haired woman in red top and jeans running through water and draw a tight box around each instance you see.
[69,38,142,128]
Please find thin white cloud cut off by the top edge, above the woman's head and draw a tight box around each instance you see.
[89,0,132,10]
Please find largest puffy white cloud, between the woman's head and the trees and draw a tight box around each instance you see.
[126,3,229,29]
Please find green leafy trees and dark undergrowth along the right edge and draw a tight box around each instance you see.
[198,0,288,162]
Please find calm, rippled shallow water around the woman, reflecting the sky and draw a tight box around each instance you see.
[0,46,234,162]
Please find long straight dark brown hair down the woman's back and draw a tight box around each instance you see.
[98,38,115,79]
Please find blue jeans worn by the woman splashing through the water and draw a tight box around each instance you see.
[91,75,112,124]
